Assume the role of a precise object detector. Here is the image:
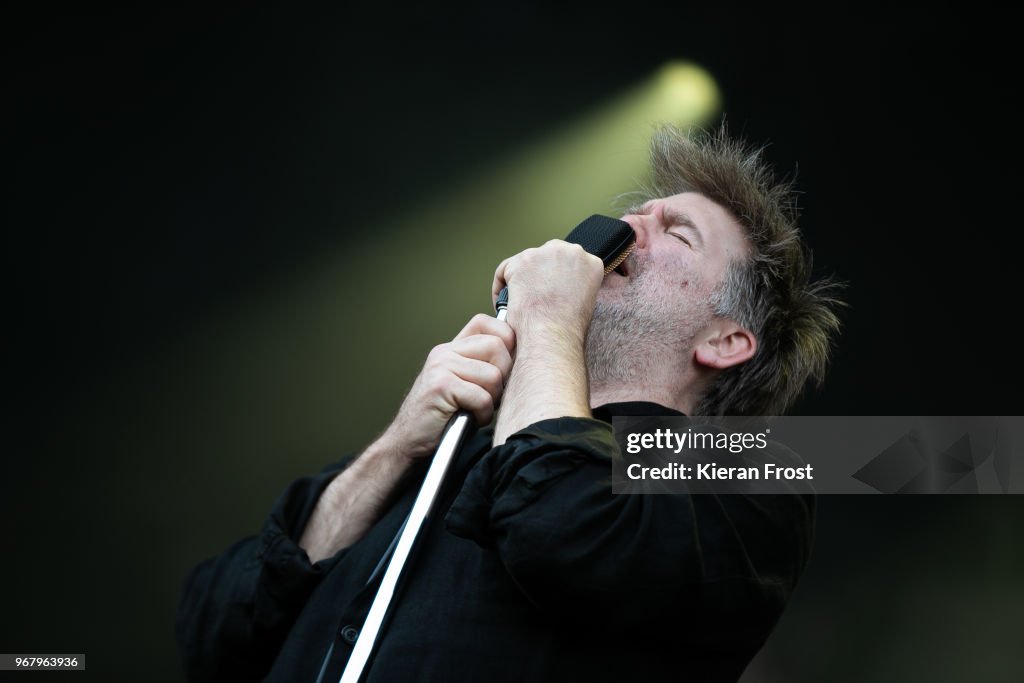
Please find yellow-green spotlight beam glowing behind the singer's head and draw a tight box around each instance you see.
[81,62,720,480]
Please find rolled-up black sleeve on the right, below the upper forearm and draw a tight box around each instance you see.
[446,418,813,639]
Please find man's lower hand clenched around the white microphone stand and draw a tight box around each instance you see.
[381,313,515,459]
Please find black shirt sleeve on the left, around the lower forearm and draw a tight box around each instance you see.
[175,464,345,681]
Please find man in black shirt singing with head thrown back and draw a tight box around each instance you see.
[177,127,839,683]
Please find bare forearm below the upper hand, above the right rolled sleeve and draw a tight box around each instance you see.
[494,322,590,445]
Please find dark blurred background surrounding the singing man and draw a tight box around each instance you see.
[0,6,1024,682]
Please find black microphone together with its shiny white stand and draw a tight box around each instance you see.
[335,214,636,683]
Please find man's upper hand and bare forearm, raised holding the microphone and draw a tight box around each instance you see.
[493,240,604,445]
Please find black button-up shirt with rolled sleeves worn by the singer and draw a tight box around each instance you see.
[177,403,813,683]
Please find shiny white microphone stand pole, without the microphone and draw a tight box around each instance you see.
[339,301,508,683]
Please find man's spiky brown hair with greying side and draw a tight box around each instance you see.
[641,125,843,415]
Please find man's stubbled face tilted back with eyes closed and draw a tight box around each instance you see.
[587,193,748,383]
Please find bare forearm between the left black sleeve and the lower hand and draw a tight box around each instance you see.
[299,432,413,562]
